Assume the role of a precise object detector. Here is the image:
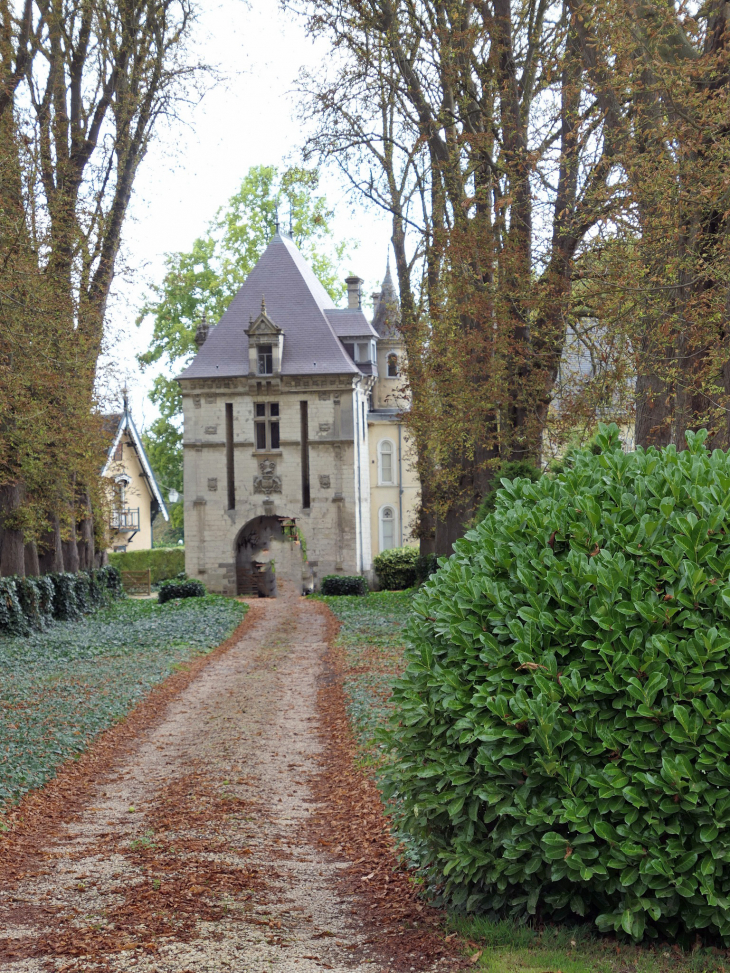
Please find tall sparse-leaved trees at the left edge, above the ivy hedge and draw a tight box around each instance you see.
[0,0,198,574]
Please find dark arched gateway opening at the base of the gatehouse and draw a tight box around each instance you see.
[230,515,304,598]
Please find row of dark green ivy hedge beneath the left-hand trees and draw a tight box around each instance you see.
[0,565,124,635]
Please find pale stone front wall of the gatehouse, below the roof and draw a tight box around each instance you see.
[181,375,371,595]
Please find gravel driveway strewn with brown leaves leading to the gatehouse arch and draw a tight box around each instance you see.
[0,594,450,973]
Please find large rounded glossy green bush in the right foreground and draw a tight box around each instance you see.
[386,426,730,942]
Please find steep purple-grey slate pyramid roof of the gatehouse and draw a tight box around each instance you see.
[179,233,359,379]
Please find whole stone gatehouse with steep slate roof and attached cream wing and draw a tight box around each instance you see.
[179,233,417,594]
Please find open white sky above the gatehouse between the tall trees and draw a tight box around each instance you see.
[108,0,390,427]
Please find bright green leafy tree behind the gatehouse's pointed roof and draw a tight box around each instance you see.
[137,166,347,504]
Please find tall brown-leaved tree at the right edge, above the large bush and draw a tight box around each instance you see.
[570,0,730,449]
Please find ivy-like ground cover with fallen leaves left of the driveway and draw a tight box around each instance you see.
[0,595,246,812]
